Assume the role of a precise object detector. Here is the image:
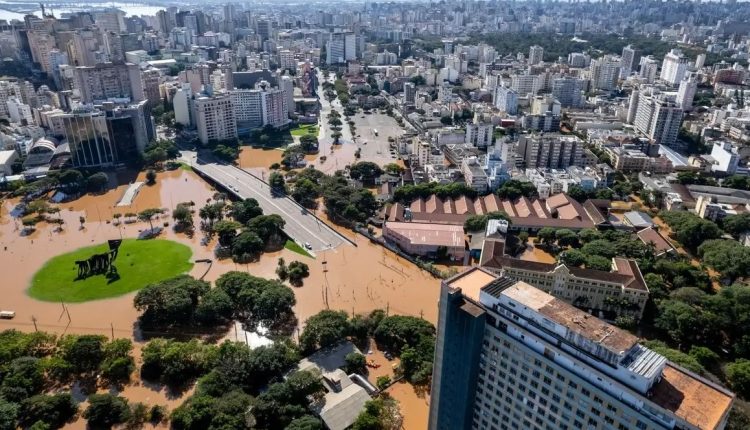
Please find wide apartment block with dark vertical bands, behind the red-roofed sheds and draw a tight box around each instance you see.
[516,133,584,169]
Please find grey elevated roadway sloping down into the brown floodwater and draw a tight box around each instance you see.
[182,151,350,252]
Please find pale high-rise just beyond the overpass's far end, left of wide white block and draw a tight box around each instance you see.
[193,95,237,145]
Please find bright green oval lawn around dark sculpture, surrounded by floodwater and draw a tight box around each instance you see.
[27,239,193,303]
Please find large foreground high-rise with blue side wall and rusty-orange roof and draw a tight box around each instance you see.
[428,268,734,430]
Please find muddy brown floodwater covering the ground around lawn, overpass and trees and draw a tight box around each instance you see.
[0,170,440,430]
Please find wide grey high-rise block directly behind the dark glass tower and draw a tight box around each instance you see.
[74,63,145,103]
